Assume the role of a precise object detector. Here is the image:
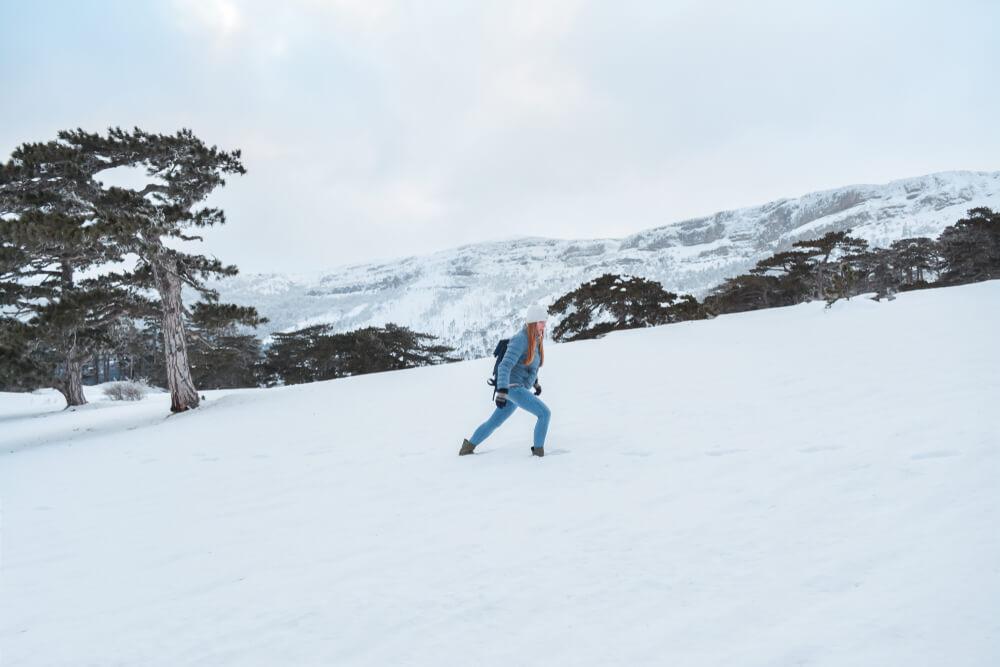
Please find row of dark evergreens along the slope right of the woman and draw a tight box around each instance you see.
[549,208,1000,341]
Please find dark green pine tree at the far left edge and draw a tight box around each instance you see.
[0,142,138,406]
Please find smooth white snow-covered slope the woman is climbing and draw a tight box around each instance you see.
[0,282,1000,667]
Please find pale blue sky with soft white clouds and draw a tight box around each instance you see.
[0,0,1000,272]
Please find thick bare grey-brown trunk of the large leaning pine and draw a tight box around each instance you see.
[152,248,199,412]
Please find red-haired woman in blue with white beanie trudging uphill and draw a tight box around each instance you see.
[458,306,551,456]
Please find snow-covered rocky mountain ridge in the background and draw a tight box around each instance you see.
[219,172,1000,357]
